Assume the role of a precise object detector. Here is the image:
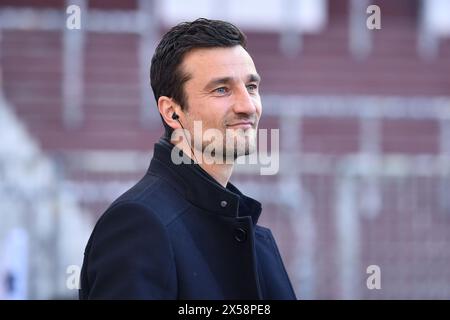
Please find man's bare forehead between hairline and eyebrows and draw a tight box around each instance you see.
[182,46,256,81]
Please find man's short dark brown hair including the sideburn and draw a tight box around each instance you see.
[150,18,247,137]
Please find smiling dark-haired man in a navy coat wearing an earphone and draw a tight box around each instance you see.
[80,19,295,299]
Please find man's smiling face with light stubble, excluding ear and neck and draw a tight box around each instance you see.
[181,46,261,159]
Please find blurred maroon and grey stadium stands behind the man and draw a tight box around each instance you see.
[0,0,450,299]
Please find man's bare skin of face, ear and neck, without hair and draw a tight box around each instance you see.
[166,45,261,182]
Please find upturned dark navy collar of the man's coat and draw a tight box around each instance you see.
[148,138,261,224]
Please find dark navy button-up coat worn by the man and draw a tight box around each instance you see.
[80,140,296,299]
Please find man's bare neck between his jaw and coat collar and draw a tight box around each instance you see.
[171,141,234,188]
